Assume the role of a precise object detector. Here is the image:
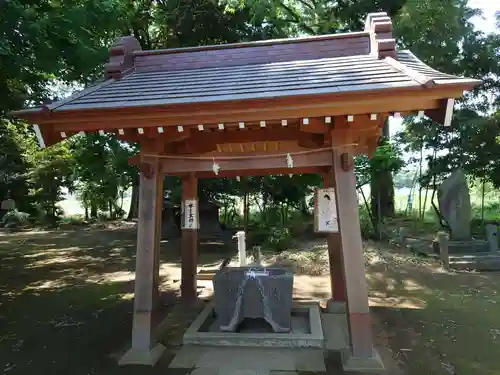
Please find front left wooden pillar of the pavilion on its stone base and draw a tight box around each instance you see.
[120,163,165,365]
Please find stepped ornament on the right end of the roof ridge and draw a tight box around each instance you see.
[365,12,397,59]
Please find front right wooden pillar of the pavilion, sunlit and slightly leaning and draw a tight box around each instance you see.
[333,149,378,368]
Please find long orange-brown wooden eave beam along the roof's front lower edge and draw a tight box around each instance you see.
[31,86,463,131]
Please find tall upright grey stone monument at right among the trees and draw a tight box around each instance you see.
[438,169,471,240]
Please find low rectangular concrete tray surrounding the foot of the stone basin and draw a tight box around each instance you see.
[183,304,324,348]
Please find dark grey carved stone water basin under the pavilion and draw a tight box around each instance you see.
[213,267,293,332]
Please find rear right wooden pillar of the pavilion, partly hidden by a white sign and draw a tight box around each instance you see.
[323,170,346,313]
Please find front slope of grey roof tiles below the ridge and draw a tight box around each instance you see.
[50,55,418,111]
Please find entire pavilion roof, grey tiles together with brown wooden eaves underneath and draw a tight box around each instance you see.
[12,13,480,153]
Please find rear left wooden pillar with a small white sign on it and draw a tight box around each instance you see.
[181,174,199,303]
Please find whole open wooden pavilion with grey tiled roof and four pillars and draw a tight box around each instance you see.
[14,13,480,370]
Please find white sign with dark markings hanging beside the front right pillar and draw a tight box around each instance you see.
[314,188,339,233]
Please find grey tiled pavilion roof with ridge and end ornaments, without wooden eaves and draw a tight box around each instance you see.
[14,13,479,117]
